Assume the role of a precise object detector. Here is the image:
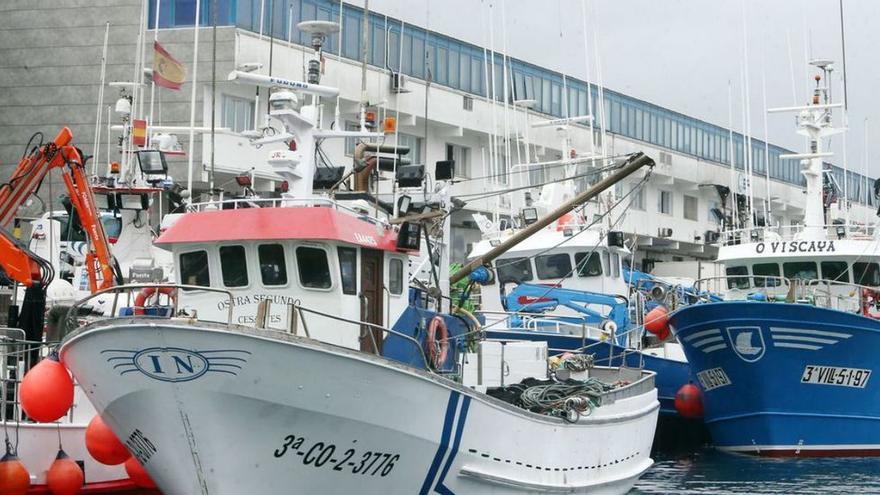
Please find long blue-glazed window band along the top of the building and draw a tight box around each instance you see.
[149,0,874,205]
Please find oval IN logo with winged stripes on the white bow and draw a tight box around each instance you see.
[101,347,250,382]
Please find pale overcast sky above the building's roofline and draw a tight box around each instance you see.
[354,0,880,176]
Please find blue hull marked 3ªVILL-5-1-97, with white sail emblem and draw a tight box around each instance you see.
[670,301,880,456]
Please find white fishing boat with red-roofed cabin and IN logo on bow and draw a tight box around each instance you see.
[49,23,659,494]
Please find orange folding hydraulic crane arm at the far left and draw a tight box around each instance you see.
[0,127,116,292]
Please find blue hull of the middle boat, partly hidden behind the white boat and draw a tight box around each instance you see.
[486,330,691,416]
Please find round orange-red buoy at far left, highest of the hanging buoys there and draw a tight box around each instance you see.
[19,354,73,423]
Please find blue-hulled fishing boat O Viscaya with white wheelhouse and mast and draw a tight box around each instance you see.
[669,61,880,456]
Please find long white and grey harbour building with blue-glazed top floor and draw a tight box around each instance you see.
[0,0,874,270]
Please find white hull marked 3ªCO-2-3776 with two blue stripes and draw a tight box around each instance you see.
[61,319,659,495]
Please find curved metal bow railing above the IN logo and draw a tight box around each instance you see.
[65,283,235,330]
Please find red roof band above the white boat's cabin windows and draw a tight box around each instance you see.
[156,207,397,251]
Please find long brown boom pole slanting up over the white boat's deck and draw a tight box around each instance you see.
[449,152,654,284]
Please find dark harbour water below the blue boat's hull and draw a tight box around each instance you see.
[630,449,880,495]
